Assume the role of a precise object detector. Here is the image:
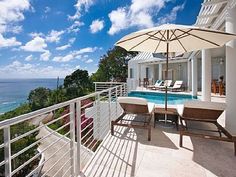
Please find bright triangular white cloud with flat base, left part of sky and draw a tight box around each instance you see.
[20,36,47,52]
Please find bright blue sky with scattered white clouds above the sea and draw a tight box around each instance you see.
[0,0,202,78]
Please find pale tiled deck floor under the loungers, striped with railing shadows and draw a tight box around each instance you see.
[83,118,236,177]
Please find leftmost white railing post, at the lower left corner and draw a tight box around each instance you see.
[3,126,11,177]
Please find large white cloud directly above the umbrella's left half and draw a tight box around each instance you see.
[108,0,183,35]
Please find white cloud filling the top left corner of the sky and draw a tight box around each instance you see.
[0,0,30,33]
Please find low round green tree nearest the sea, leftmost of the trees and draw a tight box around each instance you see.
[28,87,52,111]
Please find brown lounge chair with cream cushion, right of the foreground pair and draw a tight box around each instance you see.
[177,101,236,156]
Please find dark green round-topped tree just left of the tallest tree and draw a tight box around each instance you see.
[64,69,93,99]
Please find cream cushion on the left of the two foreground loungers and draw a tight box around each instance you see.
[117,97,155,113]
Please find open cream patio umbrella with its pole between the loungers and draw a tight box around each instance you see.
[115,24,236,110]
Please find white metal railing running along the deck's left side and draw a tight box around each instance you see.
[0,83,127,177]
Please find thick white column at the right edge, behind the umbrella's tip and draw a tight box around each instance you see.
[225,7,236,135]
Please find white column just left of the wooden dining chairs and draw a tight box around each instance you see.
[202,49,211,101]
